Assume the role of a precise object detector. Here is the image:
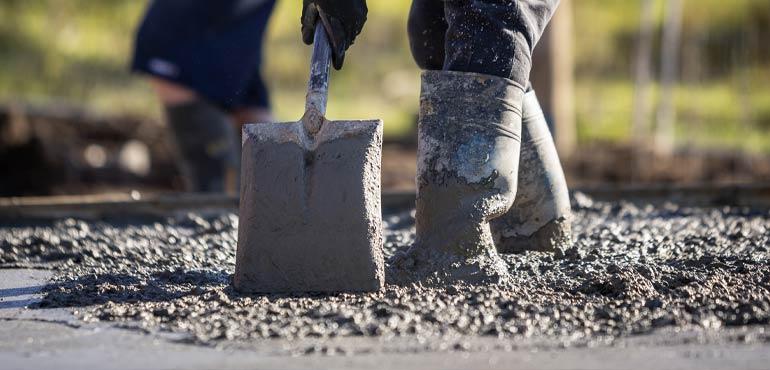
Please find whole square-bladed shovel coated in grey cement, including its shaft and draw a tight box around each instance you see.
[233,21,385,293]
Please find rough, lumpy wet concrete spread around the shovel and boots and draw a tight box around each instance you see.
[0,194,770,351]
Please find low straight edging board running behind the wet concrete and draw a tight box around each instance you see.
[0,183,770,220]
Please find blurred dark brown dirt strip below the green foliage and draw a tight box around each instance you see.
[0,105,770,196]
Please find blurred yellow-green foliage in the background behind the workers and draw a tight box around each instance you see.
[0,0,770,151]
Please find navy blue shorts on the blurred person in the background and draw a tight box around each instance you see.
[131,0,276,110]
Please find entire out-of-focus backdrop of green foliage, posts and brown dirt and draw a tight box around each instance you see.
[0,0,770,196]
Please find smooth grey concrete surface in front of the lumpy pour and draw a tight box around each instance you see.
[0,269,770,370]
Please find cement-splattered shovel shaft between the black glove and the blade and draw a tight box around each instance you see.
[305,19,332,116]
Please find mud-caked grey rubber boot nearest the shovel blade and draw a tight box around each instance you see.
[394,71,524,284]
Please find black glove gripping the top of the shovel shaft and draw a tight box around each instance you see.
[302,0,368,69]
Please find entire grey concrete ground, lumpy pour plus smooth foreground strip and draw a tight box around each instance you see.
[0,194,770,368]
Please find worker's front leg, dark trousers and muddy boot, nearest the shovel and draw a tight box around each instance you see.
[402,0,556,282]
